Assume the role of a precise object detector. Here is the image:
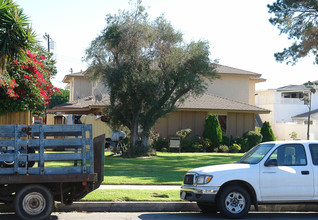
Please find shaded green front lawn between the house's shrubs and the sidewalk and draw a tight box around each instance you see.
[103,152,242,185]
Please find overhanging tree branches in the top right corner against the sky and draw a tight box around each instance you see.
[268,0,318,64]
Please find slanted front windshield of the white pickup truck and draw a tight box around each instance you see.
[237,144,275,164]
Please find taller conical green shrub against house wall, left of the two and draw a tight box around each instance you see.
[202,114,223,148]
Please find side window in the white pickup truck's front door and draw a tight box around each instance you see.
[269,144,307,166]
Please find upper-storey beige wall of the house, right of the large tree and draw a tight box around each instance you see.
[207,74,254,103]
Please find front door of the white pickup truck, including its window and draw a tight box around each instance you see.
[260,144,314,201]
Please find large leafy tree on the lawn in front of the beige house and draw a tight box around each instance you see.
[85,1,215,155]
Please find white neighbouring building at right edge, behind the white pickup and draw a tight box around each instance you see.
[255,85,318,140]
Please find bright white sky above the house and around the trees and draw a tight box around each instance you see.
[15,0,318,90]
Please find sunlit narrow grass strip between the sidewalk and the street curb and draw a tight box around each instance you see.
[81,189,181,202]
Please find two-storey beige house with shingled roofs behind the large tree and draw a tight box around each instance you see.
[49,65,270,137]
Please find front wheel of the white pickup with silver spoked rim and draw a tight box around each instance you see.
[217,185,251,218]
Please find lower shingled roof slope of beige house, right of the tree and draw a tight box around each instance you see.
[177,94,270,113]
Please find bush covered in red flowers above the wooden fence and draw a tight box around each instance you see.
[0,50,59,114]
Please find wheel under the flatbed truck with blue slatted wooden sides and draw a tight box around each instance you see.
[14,185,54,220]
